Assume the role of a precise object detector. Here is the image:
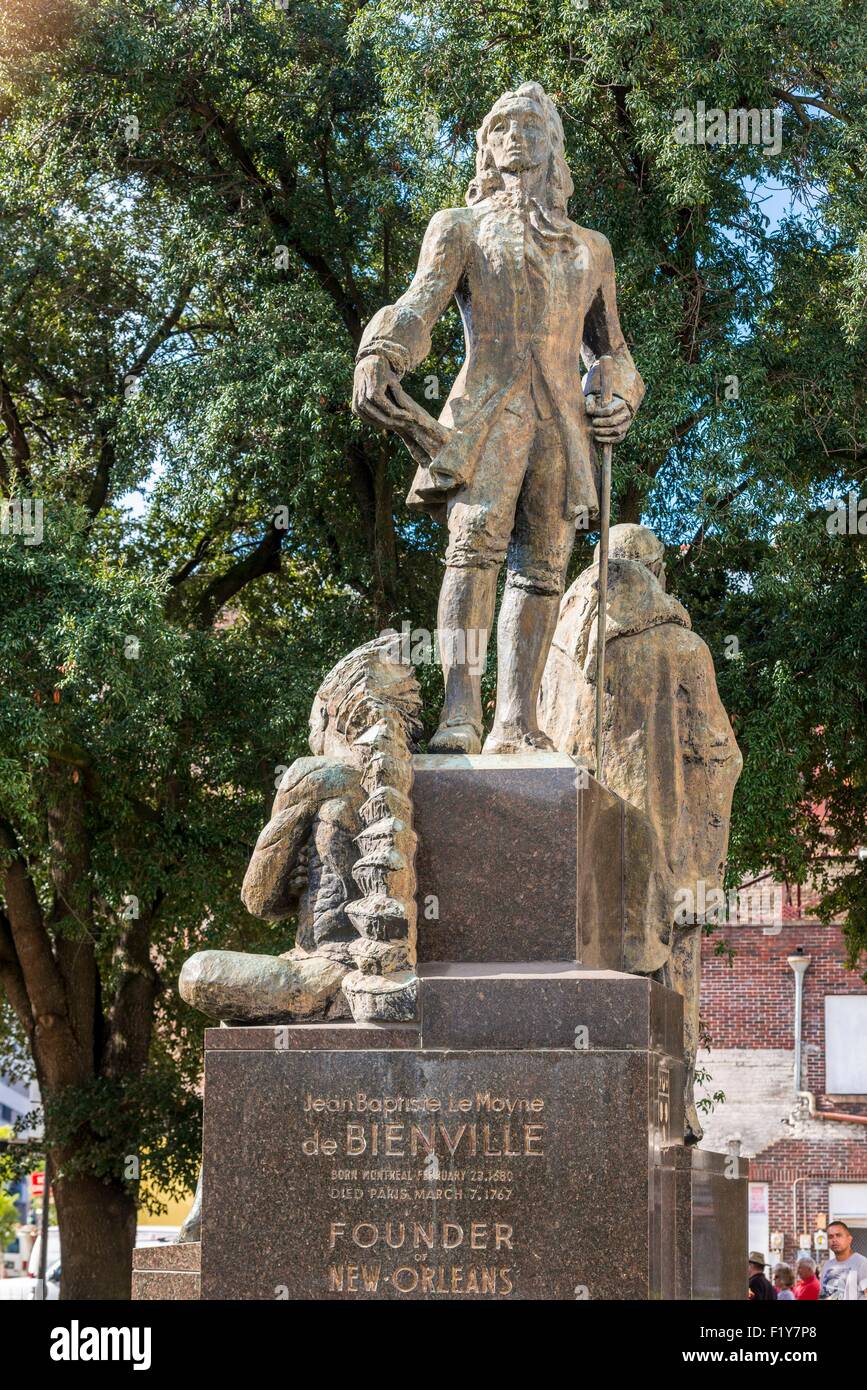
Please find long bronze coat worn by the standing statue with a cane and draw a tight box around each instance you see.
[358,193,645,518]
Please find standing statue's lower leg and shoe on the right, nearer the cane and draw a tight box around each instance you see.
[484,581,560,753]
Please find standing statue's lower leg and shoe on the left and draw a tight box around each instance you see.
[428,564,497,753]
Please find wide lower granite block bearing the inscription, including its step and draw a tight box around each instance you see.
[201,963,682,1300]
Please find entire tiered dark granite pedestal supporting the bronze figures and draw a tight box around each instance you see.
[138,755,746,1300]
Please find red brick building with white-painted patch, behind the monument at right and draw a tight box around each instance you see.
[700,890,867,1262]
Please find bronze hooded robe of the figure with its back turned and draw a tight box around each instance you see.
[539,560,742,974]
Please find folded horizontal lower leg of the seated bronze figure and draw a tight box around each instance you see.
[178,951,352,1023]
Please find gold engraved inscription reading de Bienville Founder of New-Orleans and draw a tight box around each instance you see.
[299,1090,547,1298]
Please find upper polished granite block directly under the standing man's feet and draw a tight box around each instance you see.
[413,753,624,970]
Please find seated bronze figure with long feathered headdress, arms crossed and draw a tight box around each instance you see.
[179,635,421,1023]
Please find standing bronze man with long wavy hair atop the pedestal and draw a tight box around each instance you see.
[353,82,643,753]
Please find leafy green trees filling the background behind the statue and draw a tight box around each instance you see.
[0,0,867,1297]
